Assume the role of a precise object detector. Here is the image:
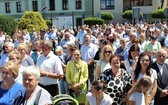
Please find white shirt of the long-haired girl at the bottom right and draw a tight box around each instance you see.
[129,92,145,105]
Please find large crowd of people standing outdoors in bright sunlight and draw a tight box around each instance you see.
[0,22,168,105]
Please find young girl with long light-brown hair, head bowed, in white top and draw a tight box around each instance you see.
[127,76,152,105]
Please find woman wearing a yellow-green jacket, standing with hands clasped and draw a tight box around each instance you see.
[66,49,88,105]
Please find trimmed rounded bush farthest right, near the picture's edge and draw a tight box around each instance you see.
[152,9,166,19]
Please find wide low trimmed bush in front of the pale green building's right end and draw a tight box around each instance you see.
[84,17,104,26]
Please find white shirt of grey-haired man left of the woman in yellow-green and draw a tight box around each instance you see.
[36,51,63,85]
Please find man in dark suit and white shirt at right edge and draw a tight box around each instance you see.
[152,49,168,105]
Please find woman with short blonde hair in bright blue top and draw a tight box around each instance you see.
[0,61,25,105]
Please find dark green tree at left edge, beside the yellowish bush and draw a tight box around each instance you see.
[0,15,18,36]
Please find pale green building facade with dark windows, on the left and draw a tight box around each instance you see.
[0,0,93,26]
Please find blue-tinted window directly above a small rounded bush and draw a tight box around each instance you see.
[100,0,115,9]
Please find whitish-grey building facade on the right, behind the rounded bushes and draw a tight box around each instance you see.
[94,0,159,23]
